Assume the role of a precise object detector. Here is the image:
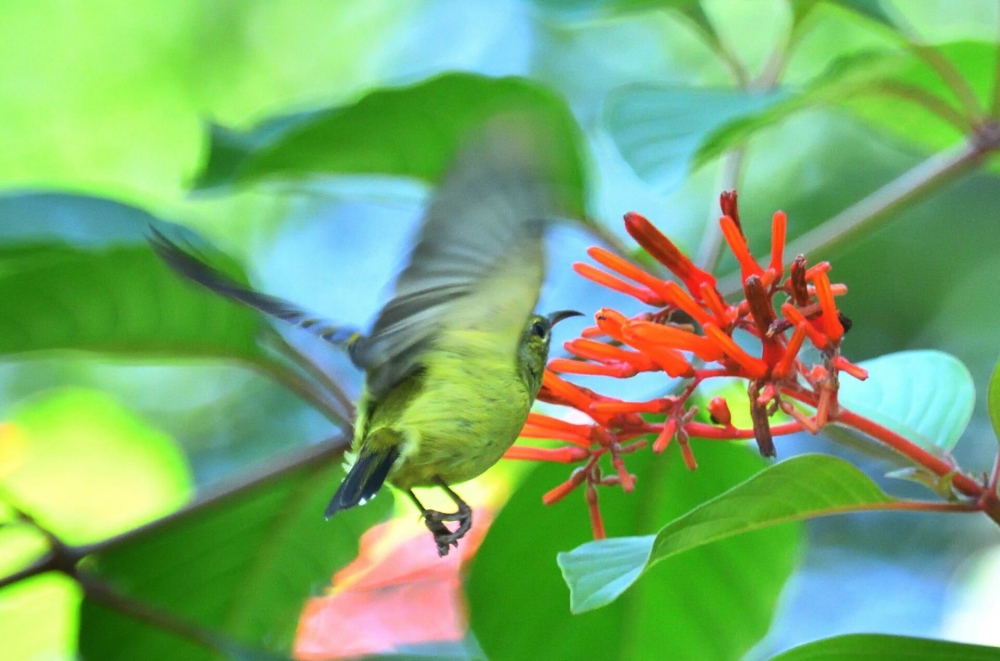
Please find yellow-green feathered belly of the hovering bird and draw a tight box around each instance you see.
[389,360,531,489]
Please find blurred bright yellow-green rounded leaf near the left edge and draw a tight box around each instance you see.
[0,389,192,545]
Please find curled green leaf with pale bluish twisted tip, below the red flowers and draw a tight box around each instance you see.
[558,455,896,613]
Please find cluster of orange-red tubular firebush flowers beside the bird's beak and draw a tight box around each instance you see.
[506,191,867,539]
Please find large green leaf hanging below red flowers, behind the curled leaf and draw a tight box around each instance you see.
[468,440,800,661]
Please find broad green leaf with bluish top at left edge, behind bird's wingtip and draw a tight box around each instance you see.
[0,193,267,360]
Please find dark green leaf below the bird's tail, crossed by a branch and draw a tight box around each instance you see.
[80,449,392,661]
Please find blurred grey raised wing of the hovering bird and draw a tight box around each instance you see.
[351,115,565,399]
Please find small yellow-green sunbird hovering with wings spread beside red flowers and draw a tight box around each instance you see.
[151,115,580,556]
